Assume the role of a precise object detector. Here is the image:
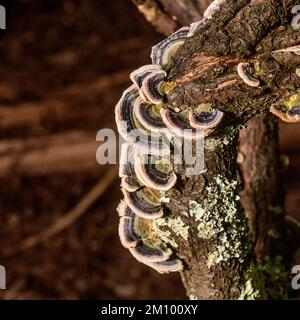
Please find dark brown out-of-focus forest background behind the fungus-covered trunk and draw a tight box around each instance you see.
[0,0,300,299]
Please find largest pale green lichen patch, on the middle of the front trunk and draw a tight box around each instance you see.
[189,175,250,267]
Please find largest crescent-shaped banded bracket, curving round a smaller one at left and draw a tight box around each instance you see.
[115,85,170,154]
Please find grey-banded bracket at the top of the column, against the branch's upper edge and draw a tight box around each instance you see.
[151,27,190,66]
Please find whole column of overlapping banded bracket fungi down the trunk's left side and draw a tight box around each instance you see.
[115,18,223,273]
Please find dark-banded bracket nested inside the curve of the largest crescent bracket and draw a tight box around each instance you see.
[133,98,169,133]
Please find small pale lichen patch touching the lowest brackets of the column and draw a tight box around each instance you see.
[153,217,189,248]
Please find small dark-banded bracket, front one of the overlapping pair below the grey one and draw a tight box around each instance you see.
[140,70,167,104]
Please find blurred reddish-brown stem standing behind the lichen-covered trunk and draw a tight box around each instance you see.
[238,114,284,262]
